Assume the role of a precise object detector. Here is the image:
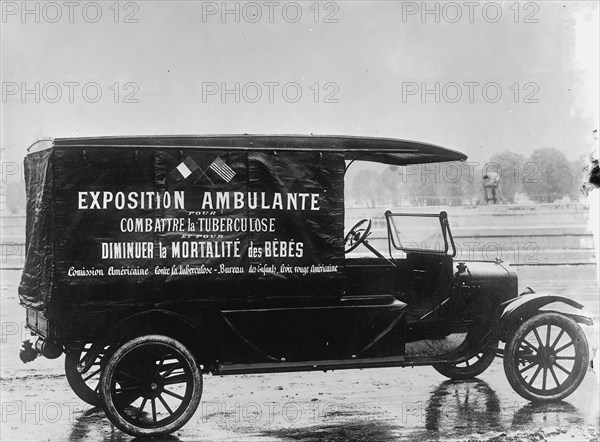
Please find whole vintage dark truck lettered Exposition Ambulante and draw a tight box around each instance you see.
[19,135,591,436]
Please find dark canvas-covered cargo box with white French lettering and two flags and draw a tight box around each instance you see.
[19,139,344,318]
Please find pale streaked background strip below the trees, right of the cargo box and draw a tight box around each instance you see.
[346,203,596,265]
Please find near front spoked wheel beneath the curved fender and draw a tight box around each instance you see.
[504,312,589,402]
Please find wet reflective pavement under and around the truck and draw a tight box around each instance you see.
[0,266,600,441]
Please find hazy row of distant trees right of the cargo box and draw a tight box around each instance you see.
[348,148,585,207]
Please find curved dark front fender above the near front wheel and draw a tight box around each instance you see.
[498,293,586,336]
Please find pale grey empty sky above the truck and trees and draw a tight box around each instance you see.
[0,1,600,169]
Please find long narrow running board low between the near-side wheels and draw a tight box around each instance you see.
[213,356,405,376]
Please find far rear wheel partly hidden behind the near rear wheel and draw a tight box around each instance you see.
[65,344,106,407]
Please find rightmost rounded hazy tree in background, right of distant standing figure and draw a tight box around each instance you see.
[523,147,574,203]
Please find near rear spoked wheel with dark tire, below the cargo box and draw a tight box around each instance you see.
[100,335,202,437]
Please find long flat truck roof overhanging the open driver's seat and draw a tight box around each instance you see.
[28,134,467,166]
